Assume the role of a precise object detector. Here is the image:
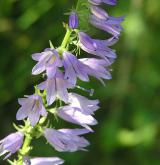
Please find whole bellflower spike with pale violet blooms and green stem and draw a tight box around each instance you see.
[0,0,124,165]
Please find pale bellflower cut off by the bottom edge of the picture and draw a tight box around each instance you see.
[30,157,64,165]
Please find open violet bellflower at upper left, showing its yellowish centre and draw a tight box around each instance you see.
[32,48,62,78]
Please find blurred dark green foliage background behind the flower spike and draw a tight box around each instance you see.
[0,0,160,165]
